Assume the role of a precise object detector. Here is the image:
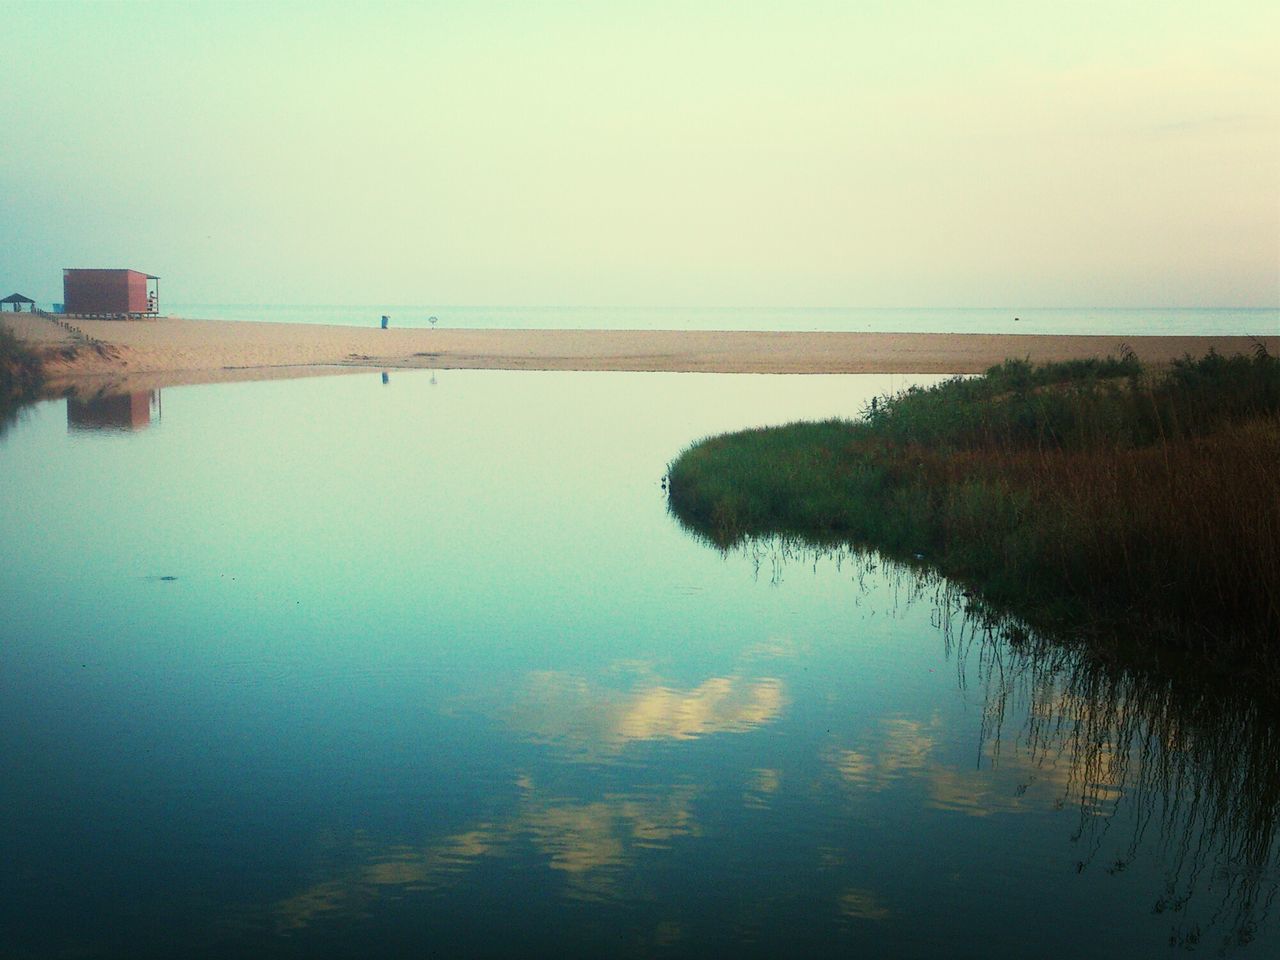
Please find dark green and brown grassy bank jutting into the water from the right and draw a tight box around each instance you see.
[669,347,1280,658]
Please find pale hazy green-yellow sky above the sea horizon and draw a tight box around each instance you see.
[0,0,1280,306]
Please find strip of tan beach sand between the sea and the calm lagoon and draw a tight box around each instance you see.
[3,314,1280,389]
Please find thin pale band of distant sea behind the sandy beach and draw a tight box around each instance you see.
[164,303,1280,337]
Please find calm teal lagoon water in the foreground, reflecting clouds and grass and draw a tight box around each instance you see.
[0,371,1280,957]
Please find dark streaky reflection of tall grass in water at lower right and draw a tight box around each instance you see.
[938,584,1280,954]
